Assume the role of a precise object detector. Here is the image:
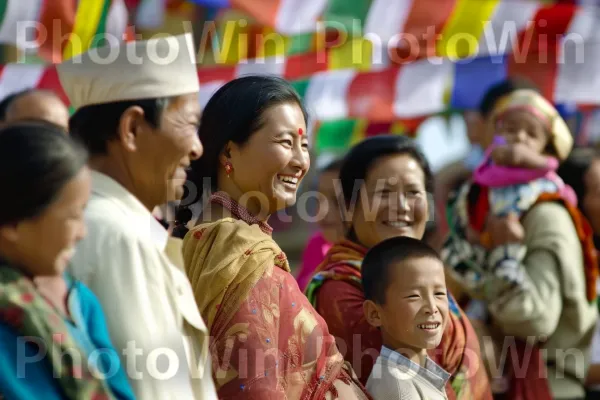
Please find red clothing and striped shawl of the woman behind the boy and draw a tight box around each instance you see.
[306,240,492,400]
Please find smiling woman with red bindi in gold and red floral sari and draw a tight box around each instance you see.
[184,76,368,400]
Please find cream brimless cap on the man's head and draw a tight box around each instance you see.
[56,33,200,109]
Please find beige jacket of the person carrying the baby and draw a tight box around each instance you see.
[486,202,598,399]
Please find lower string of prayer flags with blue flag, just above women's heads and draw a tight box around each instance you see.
[0,49,600,115]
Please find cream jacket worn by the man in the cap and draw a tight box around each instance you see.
[71,172,217,400]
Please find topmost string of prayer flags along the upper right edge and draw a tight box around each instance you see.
[206,0,600,63]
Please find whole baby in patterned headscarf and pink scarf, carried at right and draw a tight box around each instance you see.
[442,89,577,300]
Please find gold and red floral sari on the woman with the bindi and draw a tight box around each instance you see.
[183,193,369,400]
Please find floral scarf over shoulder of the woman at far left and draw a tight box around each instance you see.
[0,261,113,400]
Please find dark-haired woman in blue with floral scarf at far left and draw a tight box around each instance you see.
[0,123,134,400]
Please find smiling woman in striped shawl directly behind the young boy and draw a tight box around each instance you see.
[306,135,491,400]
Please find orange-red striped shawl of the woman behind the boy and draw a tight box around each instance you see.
[306,240,492,400]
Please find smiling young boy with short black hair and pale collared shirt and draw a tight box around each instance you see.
[362,237,450,400]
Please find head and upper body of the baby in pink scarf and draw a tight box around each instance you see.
[473,90,577,222]
